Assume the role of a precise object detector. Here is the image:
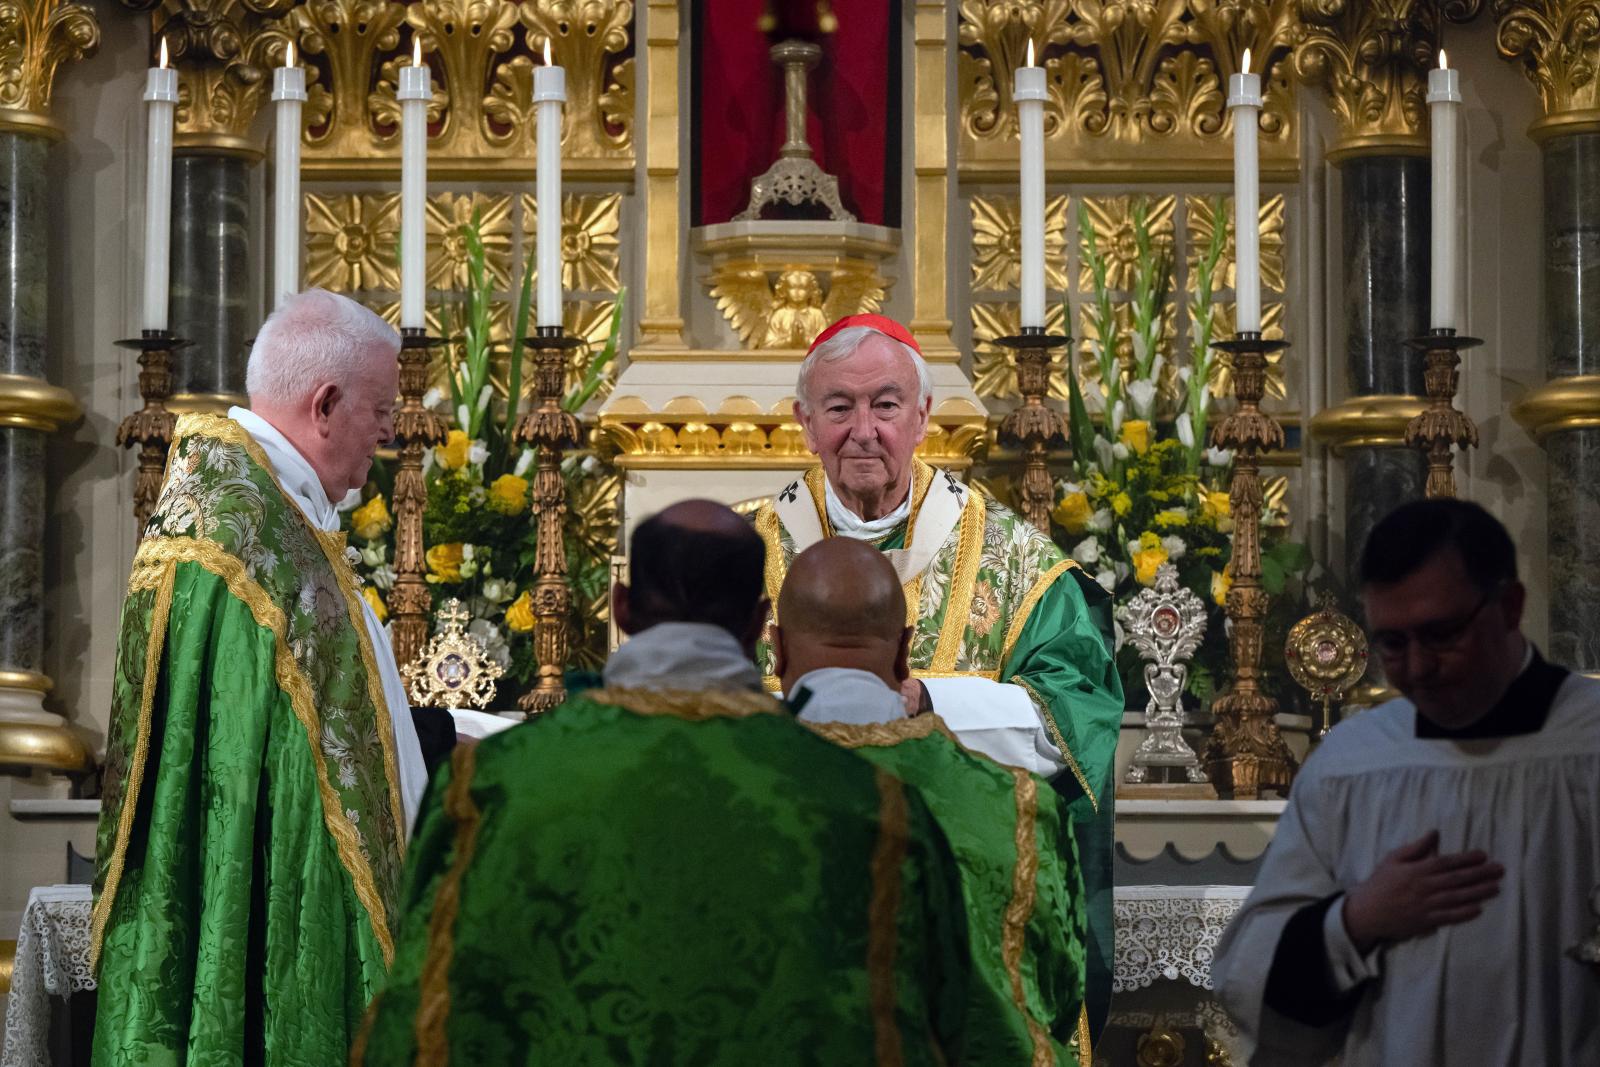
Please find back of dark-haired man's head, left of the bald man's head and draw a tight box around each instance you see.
[611,501,766,651]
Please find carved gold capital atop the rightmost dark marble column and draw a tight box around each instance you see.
[1490,0,1600,141]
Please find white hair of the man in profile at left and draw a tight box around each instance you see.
[245,290,400,406]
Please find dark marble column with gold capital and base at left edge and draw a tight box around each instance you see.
[0,0,99,771]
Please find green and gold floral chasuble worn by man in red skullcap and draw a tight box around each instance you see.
[755,461,1123,1035]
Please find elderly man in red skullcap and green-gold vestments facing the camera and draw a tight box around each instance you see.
[755,315,1123,1035]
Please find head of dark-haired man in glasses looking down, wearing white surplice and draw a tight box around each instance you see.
[1362,549,1525,729]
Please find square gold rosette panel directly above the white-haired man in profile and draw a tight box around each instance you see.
[306,194,400,293]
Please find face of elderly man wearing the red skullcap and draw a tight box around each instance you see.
[795,334,933,518]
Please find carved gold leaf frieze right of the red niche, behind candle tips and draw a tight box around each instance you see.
[957,0,1298,179]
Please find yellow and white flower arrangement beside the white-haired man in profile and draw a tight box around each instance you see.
[344,216,626,709]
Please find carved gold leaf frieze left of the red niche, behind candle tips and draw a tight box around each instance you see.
[290,0,630,179]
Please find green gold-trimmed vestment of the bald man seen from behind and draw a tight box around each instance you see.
[806,715,1086,1067]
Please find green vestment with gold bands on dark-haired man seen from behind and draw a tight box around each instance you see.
[352,688,968,1067]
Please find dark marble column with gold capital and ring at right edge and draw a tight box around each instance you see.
[1490,0,1600,672]
